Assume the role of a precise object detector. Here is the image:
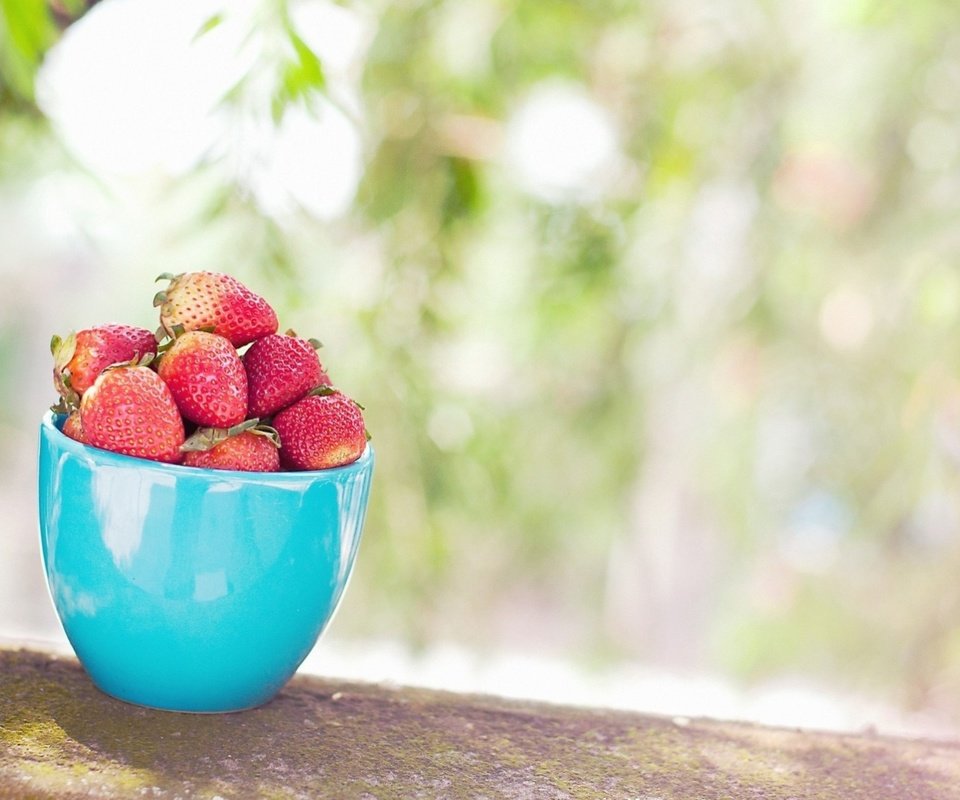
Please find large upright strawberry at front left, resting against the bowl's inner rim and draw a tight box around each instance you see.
[80,364,183,463]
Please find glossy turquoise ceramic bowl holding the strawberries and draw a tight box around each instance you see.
[39,413,374,712]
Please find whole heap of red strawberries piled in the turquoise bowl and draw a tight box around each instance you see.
[50,272,369,472]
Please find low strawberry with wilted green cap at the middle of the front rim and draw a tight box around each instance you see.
[180,420,280,472]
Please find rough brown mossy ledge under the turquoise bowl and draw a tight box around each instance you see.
[0,650,960,800]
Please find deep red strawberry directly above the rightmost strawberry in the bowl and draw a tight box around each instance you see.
[243,332,330,417]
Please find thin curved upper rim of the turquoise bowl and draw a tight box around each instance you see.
[40,409,374,484]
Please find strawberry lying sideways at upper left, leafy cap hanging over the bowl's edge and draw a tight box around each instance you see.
[50,324,157,406]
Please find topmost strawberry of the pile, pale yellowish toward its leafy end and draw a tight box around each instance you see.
[153,272,277,347]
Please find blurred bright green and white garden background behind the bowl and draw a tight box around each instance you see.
[0,0,960,734]
